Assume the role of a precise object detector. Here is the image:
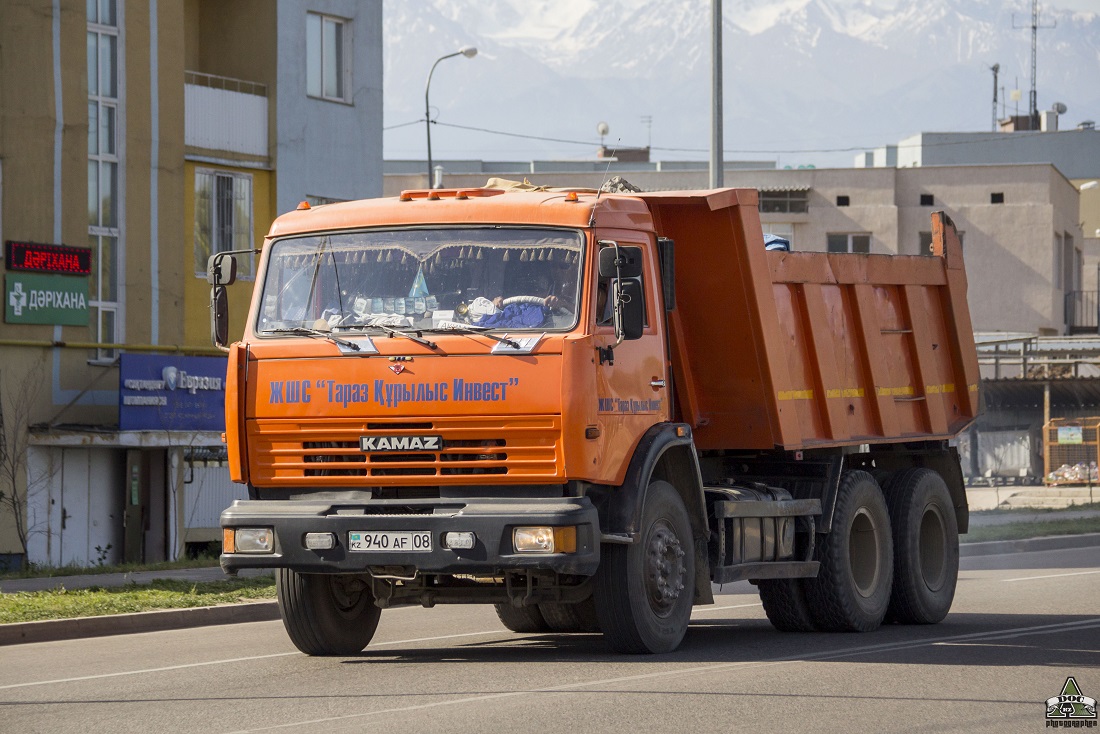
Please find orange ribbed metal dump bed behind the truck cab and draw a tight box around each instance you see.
[637,189,978,450]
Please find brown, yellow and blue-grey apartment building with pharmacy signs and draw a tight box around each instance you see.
[0,0,382,566]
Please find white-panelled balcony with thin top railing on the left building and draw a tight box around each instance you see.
[184,72,267,158]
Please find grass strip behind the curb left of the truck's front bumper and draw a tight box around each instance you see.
[0,576,275,624]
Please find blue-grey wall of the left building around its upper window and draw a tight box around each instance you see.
[273,0,382,213]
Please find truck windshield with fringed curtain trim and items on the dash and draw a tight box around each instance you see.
[256,227,584,333]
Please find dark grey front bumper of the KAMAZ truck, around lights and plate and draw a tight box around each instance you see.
[221,497,600,576]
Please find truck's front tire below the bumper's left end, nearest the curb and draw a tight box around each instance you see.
[275,568,382,655]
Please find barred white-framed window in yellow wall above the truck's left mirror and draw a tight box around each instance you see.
[195,168,252,278]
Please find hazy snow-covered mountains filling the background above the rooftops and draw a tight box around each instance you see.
[384,0,1100,166]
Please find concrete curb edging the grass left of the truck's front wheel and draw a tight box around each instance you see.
[0,601,279,646]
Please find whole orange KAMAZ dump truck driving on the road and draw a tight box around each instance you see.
[209,183,978,655]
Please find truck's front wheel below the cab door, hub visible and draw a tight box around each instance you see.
[593,481,695,655]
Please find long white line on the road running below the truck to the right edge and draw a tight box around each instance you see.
[221,617,1100,734]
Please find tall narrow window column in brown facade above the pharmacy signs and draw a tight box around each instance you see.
[86,0,121,362]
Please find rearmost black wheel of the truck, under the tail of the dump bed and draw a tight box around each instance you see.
[887,469,959,624]
